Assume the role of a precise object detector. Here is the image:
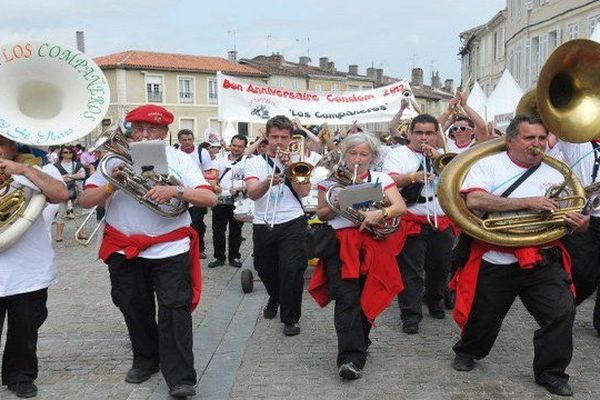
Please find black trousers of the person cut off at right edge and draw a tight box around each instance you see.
[563,217,600,332]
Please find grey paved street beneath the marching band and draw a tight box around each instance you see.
[0,209,600,400]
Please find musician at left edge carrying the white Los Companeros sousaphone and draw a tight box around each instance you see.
[0,136,69,398]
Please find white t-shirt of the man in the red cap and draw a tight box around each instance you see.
[86,146,211,259]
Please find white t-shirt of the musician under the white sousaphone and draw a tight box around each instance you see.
[0,164,63,297]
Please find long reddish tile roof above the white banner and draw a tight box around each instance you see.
[94,50,267,77]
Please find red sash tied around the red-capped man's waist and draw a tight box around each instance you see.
[98,224,202,311]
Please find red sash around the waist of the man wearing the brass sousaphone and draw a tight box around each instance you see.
[448,239,575,329]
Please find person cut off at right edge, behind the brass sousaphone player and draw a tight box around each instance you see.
[548,134,600,334]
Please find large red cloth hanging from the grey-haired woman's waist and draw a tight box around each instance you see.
[308,228,404,325]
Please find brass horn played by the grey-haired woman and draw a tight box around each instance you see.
[315,150,400,239]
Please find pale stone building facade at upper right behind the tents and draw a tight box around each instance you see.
[459,0,600,95]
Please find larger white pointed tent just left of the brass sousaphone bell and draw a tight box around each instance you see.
[482,69,523,128]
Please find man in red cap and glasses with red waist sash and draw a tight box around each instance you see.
[80,105,216,397]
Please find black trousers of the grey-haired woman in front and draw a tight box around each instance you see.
[319,227,371,368]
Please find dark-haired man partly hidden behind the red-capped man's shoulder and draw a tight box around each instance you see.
[177,129,216,259]
